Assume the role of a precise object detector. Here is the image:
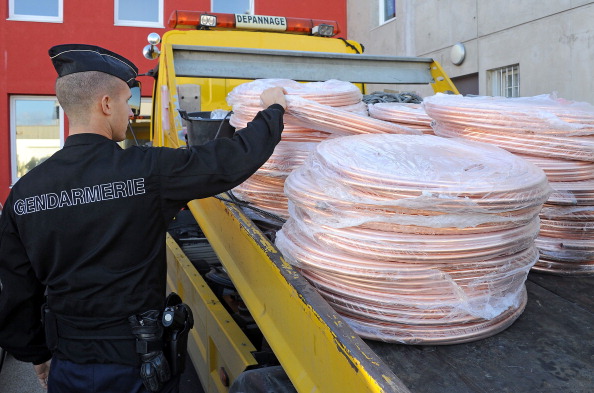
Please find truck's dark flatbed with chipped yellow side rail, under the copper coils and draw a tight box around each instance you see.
[175,198,594,393]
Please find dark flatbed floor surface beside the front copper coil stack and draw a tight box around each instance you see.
[365,272,594,393]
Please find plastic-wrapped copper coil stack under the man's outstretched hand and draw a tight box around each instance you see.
[227,79,419,218]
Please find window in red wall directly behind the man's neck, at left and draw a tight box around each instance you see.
[10,96,64,184]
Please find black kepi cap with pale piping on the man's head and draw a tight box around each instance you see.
[49,44,138,87]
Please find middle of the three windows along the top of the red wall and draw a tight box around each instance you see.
[115,0,164,28]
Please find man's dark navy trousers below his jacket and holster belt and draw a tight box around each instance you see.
[47,357,179,393]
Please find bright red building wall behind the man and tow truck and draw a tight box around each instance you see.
[0,0,346,203]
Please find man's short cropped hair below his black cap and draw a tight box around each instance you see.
[56,71,121,121]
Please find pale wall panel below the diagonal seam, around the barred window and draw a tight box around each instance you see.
[478,6,594,103]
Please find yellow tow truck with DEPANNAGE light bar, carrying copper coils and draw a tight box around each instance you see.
[134,11,594,393]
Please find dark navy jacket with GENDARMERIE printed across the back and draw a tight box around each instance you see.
[0,104,284,364]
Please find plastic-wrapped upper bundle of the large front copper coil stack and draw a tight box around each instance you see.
[285,135,550,228]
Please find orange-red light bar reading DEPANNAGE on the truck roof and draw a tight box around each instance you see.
[169,11,340,37]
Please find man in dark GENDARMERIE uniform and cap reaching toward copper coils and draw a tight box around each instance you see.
[0,44,286,393]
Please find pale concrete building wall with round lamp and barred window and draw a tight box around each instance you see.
[347,0,594,104]
